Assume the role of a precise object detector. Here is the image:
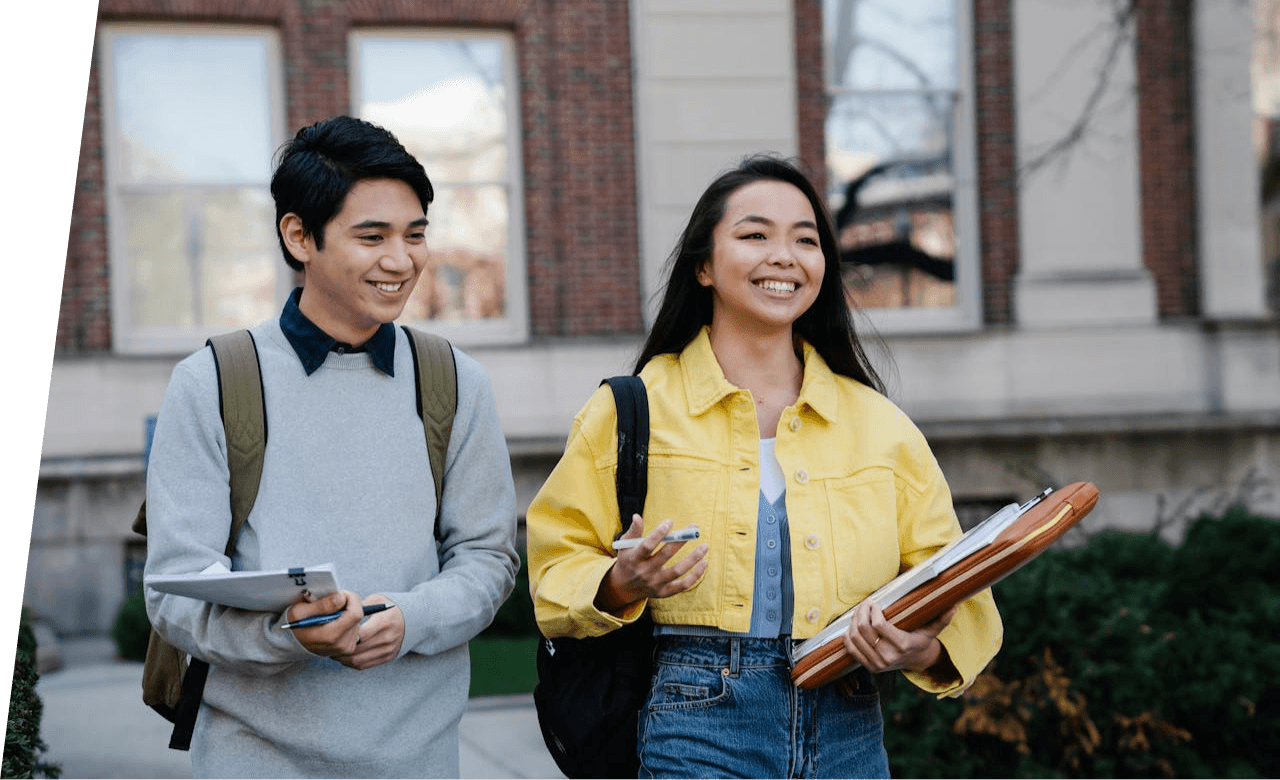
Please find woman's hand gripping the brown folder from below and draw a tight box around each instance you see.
[845,601,957,679]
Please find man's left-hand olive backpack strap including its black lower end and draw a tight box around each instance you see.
[169,330,266,751]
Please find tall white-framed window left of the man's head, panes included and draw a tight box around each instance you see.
[99,24,292,352]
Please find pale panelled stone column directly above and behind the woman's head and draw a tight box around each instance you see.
[631,0,799,325]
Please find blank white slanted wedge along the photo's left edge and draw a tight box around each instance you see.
[0,0,97,712]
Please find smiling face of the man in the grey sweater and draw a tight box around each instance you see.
[280,179,426,345]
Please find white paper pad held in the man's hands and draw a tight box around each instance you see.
[142,562,340,612]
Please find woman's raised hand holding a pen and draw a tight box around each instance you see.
[595,515,707,612]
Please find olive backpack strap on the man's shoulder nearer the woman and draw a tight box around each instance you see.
[402,325,458,530]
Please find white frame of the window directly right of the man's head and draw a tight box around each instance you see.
[347,26,530,347]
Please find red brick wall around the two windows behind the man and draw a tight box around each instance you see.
[56,0,643,355]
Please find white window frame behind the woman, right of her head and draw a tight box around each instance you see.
[822,0,983,336]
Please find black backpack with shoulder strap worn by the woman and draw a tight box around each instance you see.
[534,377,654,777]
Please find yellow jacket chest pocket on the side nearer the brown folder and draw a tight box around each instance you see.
[826,469,900,606]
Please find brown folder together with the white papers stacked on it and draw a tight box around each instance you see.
[791,482,1098,688]
